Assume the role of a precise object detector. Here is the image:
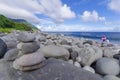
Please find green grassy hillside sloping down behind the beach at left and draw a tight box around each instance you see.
[0,15,37,32]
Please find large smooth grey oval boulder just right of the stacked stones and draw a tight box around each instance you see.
[40,45,70,60]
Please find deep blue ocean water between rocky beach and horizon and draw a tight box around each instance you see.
[46,32,120,44]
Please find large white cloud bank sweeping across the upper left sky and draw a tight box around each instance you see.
[0,0,75,23]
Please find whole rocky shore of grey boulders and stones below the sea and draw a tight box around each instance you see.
[0,31,120,80]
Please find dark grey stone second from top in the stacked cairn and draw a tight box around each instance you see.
[17,42,40,54]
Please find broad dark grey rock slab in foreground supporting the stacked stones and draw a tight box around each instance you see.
[0,59,103,80]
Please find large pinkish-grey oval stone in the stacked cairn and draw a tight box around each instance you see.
[13,52,45,69]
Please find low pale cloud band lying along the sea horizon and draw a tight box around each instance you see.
[37,24,115,31]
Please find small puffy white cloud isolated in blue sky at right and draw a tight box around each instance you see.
[81,11,105,22]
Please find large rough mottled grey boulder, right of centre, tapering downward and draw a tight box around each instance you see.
[78,46,103,66]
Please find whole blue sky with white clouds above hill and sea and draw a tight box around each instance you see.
[0,0,120,32]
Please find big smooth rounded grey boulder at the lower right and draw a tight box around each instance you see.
[96,58,120,75]
